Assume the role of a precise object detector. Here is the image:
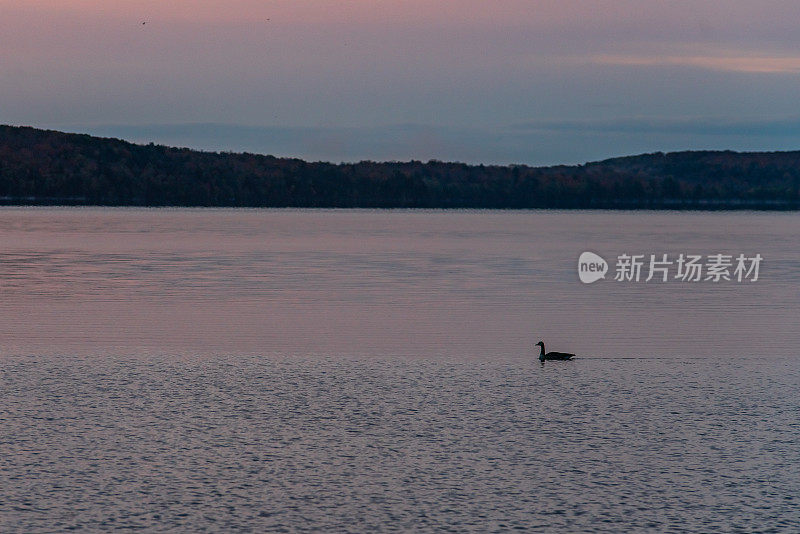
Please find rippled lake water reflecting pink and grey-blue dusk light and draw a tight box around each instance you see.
[0,208,800,532]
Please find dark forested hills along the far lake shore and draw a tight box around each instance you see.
[0,126,800,209]
